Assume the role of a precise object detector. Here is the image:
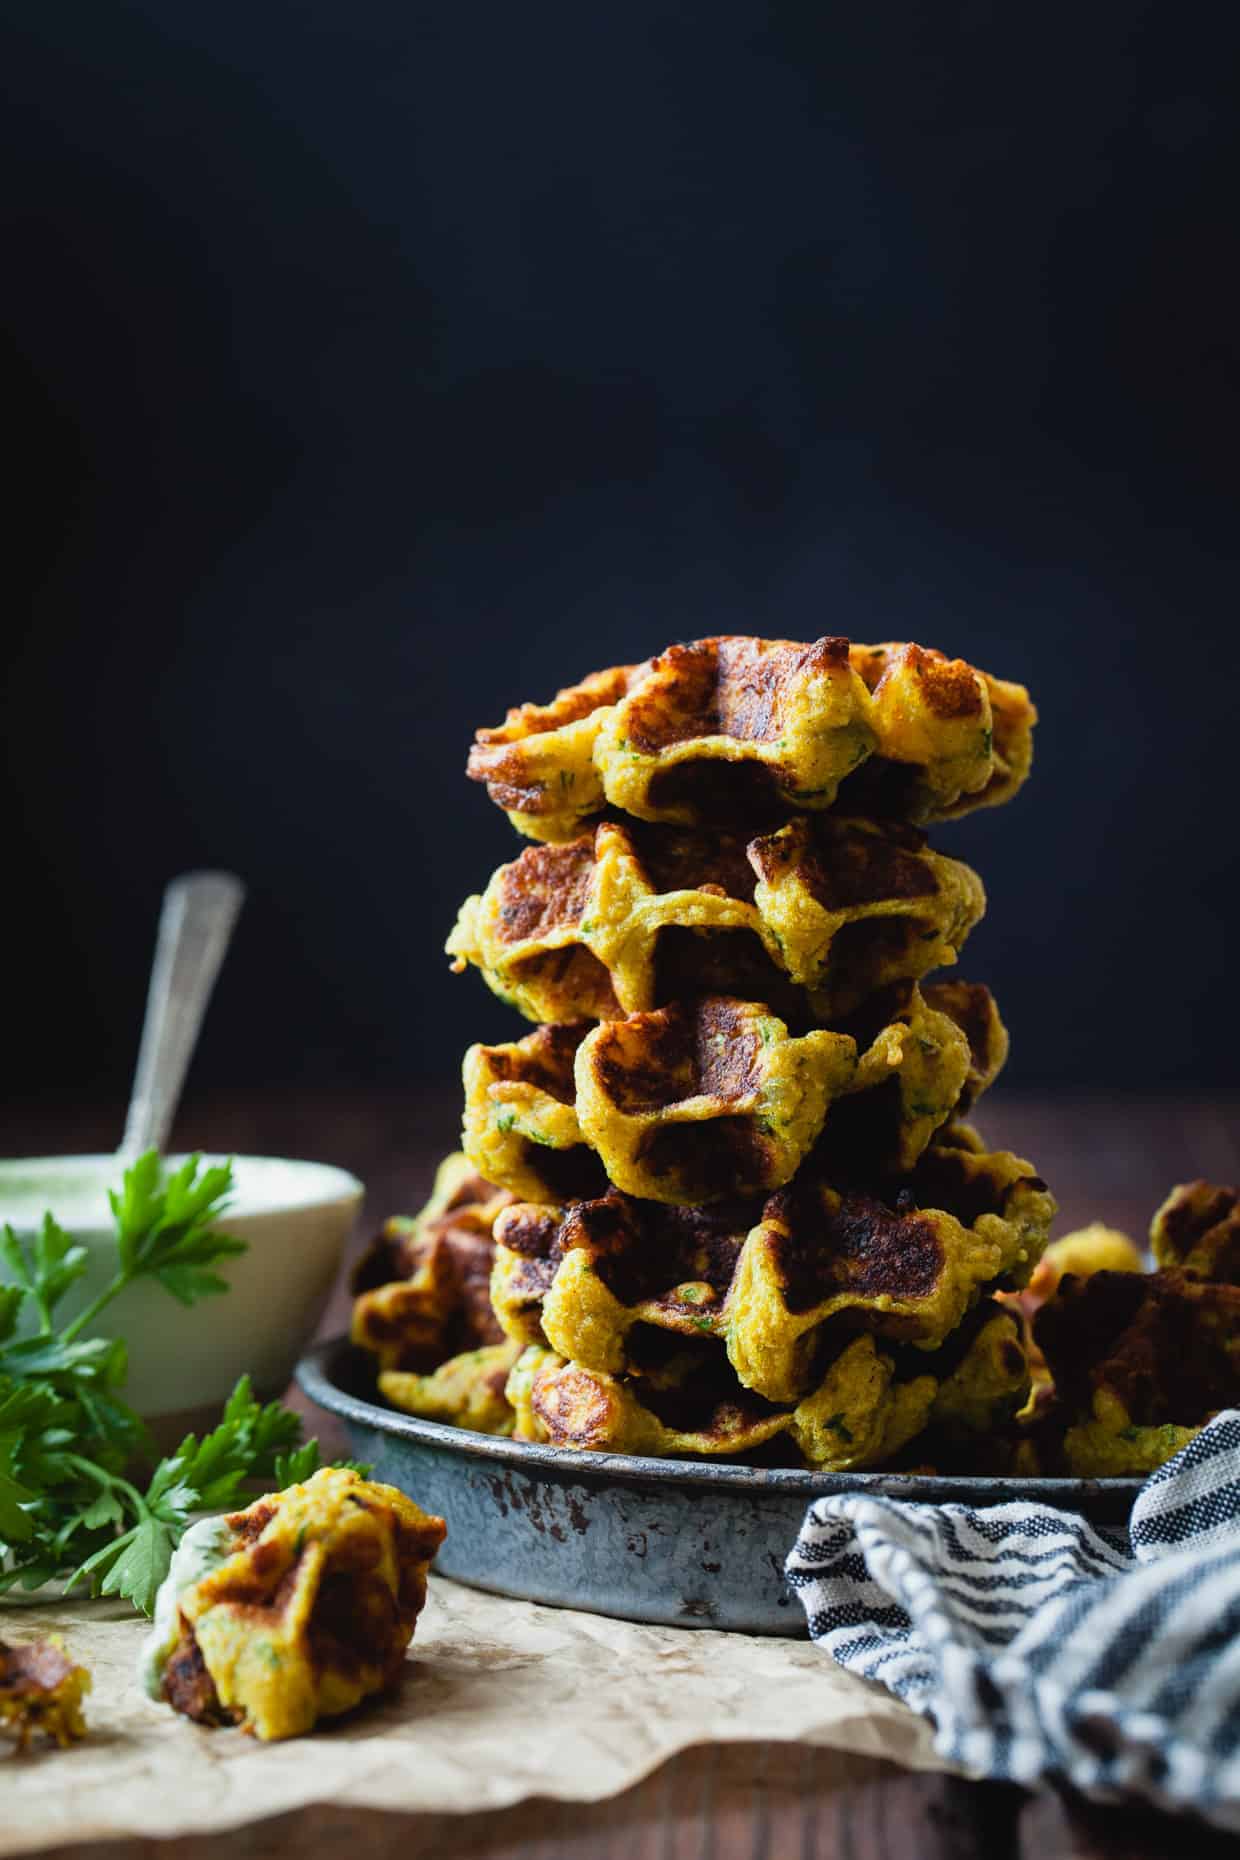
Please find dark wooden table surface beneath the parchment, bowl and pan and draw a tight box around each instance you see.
[2,1090,1240,1860]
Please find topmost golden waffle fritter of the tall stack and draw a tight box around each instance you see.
[468,636,1036,843]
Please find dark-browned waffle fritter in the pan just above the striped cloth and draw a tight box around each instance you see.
[1022,1270,1240,1479]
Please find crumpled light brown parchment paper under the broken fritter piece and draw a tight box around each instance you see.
[0,1577,946,1856]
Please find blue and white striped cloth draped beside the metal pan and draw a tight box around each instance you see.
[786,1410,1240,1830]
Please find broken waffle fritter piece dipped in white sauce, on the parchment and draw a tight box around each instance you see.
[143,1468,446,1741]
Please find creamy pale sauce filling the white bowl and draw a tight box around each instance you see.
[0,1155,359,1233]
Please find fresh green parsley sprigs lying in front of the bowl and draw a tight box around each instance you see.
[0,1151,364,1614]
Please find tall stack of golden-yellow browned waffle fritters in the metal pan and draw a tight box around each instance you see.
[355,638,1054,1469]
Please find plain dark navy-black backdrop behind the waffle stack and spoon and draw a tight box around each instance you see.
[0,0,1240,1099]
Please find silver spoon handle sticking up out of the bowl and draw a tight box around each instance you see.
[121,872,245,1155]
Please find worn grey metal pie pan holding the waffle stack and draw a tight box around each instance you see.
[297,1339,1141,1635]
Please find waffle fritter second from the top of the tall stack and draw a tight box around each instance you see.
[448,815,985,1023]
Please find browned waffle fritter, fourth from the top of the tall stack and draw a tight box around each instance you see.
[491,1148,1054,1402]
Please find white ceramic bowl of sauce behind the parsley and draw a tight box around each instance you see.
[0,1155,363,1438]
